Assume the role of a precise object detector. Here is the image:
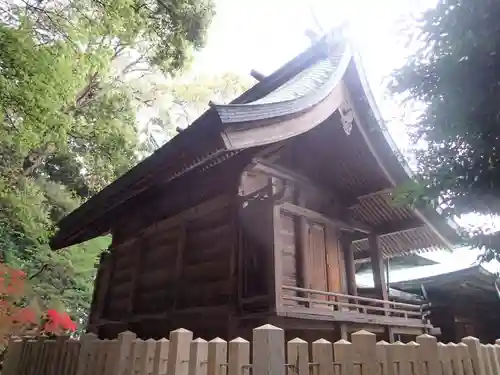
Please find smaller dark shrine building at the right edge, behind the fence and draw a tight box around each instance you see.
[391,265,500,343]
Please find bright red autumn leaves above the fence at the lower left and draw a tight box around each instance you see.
[0,263,76,341]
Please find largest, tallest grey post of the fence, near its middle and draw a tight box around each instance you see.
[252,324,285,375]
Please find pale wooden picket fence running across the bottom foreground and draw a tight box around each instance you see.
[2,325,500,375]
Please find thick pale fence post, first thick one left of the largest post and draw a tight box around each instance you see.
[167,328,193,375]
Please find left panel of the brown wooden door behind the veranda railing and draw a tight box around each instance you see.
[307,223,328,308]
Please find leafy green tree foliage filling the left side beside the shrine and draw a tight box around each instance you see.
[0,0,213,323]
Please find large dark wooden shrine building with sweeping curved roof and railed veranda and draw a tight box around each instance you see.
[51,35,456,339]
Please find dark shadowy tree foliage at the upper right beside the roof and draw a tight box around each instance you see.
[391,0,500,260]
